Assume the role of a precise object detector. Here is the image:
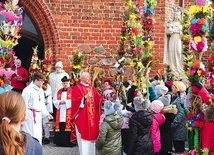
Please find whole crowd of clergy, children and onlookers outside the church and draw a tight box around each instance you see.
[0,60,214,155]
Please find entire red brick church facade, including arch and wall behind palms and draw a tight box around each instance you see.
[19,0,199,76]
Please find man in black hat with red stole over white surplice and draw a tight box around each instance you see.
[53,76,72,146]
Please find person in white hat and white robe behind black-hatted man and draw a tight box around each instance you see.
[49,61,69,117]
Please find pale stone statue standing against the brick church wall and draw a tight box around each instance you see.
[164,7,183,76]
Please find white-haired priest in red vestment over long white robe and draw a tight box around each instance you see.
[71,72,103,155]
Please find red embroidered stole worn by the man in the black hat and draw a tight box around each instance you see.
[55,88,72,132]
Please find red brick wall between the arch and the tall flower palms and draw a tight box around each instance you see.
[46,0,125,70]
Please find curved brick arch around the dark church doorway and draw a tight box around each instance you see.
[19,0,59,60]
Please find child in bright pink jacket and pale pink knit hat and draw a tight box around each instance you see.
[149,100,165,155]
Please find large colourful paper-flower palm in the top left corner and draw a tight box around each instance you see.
[0,0,23,68]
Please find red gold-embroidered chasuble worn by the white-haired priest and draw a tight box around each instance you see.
[71,83,103,141]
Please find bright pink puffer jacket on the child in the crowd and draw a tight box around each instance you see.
[150,113,165,153]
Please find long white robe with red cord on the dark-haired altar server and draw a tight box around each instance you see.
[21,82,49,144]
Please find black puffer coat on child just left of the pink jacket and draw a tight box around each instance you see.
[128,110,154,155]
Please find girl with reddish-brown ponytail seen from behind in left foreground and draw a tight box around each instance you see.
[0,91,42,155]
